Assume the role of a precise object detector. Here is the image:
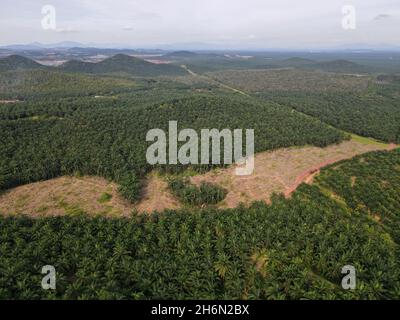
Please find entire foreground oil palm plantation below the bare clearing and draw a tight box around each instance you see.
[0,150,400,299]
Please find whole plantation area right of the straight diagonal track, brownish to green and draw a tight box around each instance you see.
[209,70,400,143]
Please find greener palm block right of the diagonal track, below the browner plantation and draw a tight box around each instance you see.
[263,85,400,143]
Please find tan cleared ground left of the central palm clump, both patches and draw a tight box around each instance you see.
[0,174,180,217]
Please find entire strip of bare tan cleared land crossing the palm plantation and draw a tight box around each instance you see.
[0,139,397,217]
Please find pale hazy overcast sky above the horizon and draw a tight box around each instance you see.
[0,0,400,49]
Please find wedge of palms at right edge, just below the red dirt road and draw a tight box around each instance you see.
[316,149,400,243]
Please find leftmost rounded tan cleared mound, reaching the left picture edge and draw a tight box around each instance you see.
[0,176,133,217]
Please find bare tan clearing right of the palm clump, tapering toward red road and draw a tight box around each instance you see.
[191,140,395,208]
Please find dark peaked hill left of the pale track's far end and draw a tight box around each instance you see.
[60,54,186,77]
